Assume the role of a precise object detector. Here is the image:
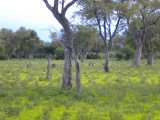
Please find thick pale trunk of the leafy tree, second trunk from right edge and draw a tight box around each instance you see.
[133,44,143,66]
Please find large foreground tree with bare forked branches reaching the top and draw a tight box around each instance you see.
[43,0,78,88]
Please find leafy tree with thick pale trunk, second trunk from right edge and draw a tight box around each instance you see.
[124,0,160,66]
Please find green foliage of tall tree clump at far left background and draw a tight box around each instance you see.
[0,27,42,59]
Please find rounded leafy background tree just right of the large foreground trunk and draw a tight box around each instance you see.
[73,25,98,63]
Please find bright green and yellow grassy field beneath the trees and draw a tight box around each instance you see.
[0,60,160,120]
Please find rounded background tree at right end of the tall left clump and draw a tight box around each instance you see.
[15,27,42,59]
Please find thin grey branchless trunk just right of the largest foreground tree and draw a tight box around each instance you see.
[75,53,81,94]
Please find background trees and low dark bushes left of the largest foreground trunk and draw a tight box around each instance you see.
[0,27,64,60]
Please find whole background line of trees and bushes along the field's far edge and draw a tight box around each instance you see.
[0,25,160,62]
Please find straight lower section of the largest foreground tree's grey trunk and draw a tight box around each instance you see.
[63,47,72,89]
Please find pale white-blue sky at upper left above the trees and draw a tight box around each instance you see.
[0,0,77,42]
